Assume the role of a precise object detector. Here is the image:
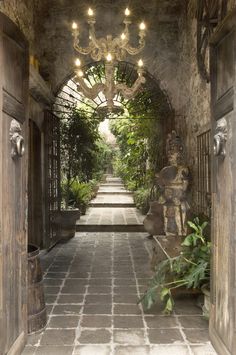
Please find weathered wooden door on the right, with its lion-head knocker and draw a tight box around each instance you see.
[210,10,236,355]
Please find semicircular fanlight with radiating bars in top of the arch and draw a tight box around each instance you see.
[54,62,174,126]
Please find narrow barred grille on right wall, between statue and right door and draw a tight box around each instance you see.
[197,130,211,217]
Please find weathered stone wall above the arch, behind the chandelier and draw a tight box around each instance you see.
[32,0,182,96]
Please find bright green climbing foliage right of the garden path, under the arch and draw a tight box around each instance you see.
[110,90,166,190]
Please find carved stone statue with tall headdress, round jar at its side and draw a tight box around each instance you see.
[144,131,189,236]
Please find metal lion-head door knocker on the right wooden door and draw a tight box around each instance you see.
[213,118,228,157]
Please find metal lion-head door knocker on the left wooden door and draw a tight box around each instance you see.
[9,120,25,158]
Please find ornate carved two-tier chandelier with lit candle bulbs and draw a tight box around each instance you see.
[72,8,146,112]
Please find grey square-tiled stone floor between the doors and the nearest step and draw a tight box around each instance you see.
[23,178,215,355]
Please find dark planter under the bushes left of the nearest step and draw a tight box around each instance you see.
[53,209,80,240]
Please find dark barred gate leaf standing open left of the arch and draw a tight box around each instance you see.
[45,111,61,248]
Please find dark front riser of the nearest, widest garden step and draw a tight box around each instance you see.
[76,224,145,233]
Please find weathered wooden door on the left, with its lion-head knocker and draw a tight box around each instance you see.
[0,13,29,355]
